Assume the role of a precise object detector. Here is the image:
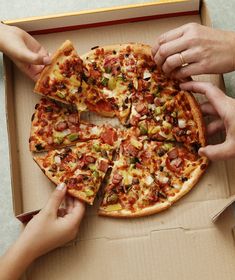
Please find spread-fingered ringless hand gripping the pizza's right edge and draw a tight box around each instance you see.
[180,81,235,160]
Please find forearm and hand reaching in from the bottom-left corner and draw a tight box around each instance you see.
[0,184,85,280]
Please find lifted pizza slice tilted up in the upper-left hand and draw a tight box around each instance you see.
[34,40,86,111]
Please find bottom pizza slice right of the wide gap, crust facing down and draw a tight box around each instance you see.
[99,133,171,217]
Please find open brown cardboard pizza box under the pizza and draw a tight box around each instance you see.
[4,0,235,280]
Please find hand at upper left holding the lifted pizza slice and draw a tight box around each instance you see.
[0,23,51,81]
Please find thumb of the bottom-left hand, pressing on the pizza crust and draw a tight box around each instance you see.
[44,183,66,216]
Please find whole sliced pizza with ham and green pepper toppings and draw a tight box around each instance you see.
[29,41,208,218]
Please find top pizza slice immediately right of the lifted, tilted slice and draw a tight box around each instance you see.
[82,44,141,124]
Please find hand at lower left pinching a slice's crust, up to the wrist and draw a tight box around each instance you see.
[19,183,85,259]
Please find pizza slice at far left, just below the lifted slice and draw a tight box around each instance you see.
[29,98,117,152]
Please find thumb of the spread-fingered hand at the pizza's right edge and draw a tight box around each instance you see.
[198,141,234,160]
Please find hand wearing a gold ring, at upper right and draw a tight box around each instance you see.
[152,23,235,79]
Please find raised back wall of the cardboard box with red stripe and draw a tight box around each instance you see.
[4,0,200,35]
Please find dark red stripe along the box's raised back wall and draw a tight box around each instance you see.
[28,10,199,35]
